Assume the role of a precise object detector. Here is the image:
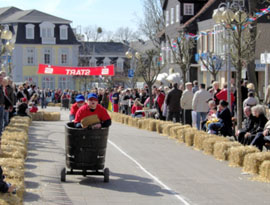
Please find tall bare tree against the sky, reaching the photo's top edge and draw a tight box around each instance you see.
[139,0,165,48]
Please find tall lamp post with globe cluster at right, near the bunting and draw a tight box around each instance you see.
[212,0,247,110]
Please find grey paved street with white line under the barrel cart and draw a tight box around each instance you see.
[24,107,270,205]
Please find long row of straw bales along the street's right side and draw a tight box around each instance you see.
[110,113,270,182]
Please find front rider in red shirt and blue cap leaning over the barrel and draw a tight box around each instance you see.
[74,93,112,129]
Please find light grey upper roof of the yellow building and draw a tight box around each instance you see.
[1,9,71,24]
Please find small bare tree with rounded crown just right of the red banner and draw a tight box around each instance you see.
[137,49,164,108]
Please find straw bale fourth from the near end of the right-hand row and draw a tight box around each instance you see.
[214,141,241,160]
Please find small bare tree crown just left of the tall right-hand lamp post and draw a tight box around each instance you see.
[200,52,223,81]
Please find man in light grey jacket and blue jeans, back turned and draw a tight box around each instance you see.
[192,83,211,130]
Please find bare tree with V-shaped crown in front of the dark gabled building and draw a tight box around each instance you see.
[167,31,195,86]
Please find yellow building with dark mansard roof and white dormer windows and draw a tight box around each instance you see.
[0,7,79,89]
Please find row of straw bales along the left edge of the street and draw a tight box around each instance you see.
[0,117,31,205]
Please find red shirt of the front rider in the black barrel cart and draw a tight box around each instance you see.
[74,104,111,123]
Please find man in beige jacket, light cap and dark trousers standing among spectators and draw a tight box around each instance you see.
[181,82,193,125]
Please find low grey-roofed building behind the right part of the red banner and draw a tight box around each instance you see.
[78,42,130,90]
